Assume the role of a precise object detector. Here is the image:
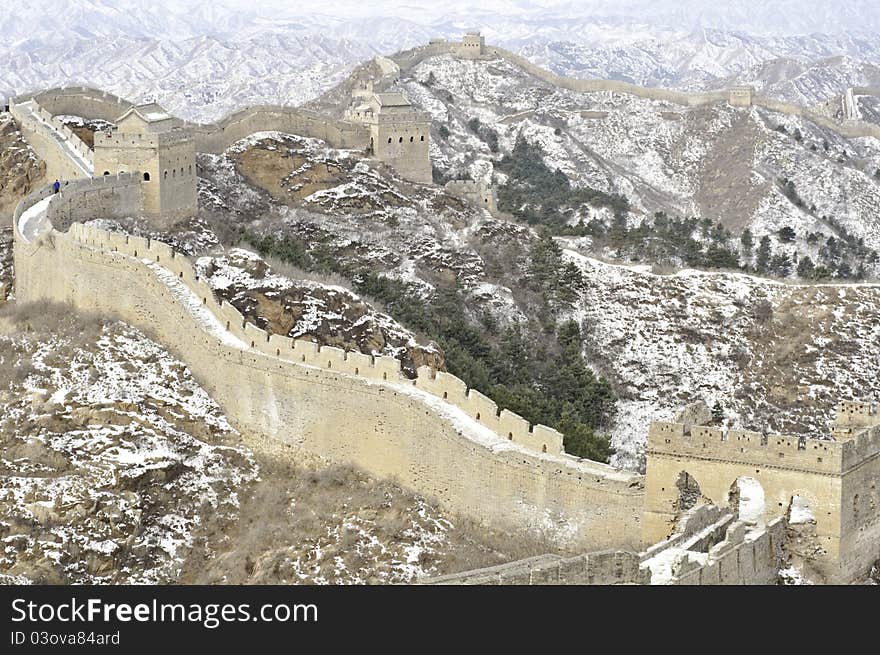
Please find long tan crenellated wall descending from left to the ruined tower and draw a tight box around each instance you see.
[15,191,644,550]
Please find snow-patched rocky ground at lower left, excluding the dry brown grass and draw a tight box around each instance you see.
[0,324,256,584]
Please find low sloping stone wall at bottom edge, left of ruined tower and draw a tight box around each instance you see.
[421,550,650,585]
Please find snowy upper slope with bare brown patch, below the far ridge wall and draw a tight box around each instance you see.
[398,55,880,274]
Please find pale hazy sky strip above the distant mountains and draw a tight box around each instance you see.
[0,0,880,36]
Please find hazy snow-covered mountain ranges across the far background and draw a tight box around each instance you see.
[0,0,880,120]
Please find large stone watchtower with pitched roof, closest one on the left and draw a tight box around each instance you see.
[95,104,198,225]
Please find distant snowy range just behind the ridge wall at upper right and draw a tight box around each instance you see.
[514,30,880,105]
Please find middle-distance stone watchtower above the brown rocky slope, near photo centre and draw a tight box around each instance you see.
[347,93,432,184]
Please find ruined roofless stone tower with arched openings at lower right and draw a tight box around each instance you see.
[643,419,880,582]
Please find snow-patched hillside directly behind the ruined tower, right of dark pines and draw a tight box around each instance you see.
[565,250,880,468]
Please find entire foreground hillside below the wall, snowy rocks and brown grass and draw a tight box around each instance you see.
[0,303,552,584]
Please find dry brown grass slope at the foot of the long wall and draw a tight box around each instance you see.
[180,444,553,584]
